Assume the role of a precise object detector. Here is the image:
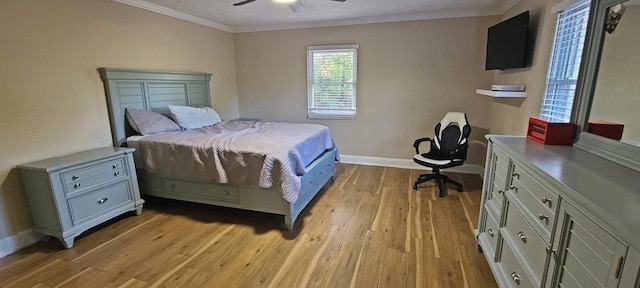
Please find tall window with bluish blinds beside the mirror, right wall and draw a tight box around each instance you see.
[540,0,590,122]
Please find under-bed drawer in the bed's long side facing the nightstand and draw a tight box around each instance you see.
[162,178,240,203]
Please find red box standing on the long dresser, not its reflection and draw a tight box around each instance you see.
[527,117,574,146]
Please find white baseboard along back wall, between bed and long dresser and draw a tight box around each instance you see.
[340,155,484,175]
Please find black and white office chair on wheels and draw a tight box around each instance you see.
[413,112,471,197]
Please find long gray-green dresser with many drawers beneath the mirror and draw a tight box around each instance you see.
[476,135,640,288]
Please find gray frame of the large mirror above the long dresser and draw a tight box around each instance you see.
[571,0,640,171]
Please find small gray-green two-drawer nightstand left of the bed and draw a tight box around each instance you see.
[17,147,144,248]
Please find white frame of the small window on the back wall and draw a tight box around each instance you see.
[307,44,360,119]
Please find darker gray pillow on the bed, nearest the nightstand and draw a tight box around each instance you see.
[125,108,182,135]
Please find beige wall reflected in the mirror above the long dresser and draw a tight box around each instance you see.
[589,5,640,142]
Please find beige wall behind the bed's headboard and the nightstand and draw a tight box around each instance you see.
[0,0,238,240]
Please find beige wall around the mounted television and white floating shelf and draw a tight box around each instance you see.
[488,0,559,135]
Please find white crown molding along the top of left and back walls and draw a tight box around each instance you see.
[112,0,520,33]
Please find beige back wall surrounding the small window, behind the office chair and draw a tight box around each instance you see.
[234,17,499,164]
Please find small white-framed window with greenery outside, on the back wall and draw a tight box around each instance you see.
[307,45,358,119]
